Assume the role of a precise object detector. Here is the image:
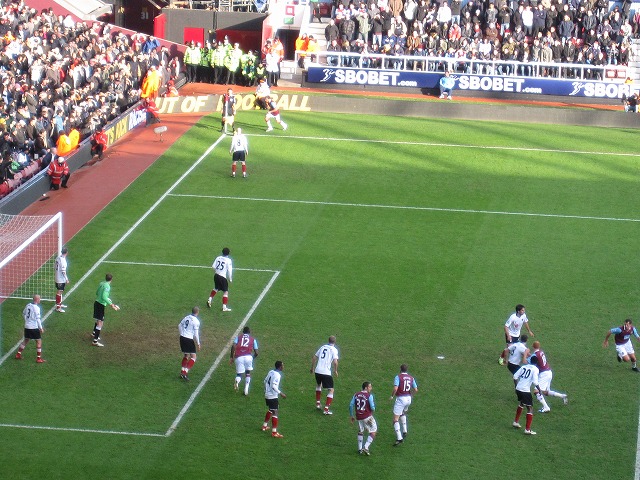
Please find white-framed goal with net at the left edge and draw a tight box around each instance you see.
[0,212,62,301]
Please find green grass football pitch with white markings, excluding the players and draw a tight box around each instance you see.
[0,112,640,480]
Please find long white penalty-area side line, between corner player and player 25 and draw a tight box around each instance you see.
[169,193,640,222]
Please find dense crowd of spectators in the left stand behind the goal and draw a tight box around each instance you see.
[0,0,180,196]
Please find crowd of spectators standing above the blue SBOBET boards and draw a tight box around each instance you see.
[300,0,640,78]
